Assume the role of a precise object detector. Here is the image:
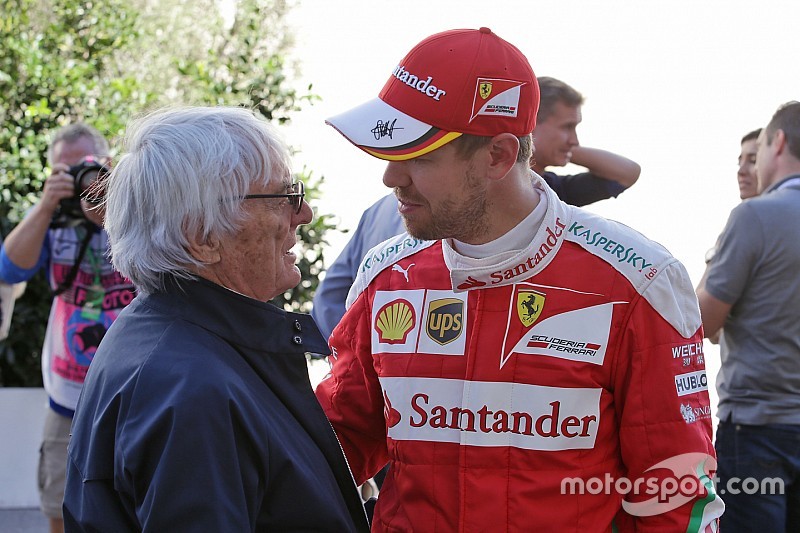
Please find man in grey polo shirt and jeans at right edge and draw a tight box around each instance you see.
[697,102,800,533]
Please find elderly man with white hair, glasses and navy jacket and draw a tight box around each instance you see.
[64,107,368,532]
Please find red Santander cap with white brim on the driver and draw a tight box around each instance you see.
[325,28,539,161]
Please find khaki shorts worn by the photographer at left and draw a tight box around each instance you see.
[38,407,72,518]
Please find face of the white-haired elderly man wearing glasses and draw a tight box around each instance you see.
[217,173,313,301]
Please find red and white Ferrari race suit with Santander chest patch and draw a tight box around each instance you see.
[317,177,724,532]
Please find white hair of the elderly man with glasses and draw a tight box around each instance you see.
[105,107,291,293]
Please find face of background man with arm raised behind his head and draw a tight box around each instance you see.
[532,102,582,172]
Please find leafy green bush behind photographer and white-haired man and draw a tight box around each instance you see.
[0,0,333,386]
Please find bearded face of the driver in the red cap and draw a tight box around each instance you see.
[383,143,488,243]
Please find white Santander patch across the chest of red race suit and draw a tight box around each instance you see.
[380,377,601,450]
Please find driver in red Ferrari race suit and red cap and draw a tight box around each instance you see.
[317,28,724,533]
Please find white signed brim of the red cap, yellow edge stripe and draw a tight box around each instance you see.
[325,98,461,161]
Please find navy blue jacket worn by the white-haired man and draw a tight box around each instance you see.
[64,280,369,533]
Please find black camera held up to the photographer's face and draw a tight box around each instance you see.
[50,156,111,228]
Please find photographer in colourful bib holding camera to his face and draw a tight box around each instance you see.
[0,123,134,531]
